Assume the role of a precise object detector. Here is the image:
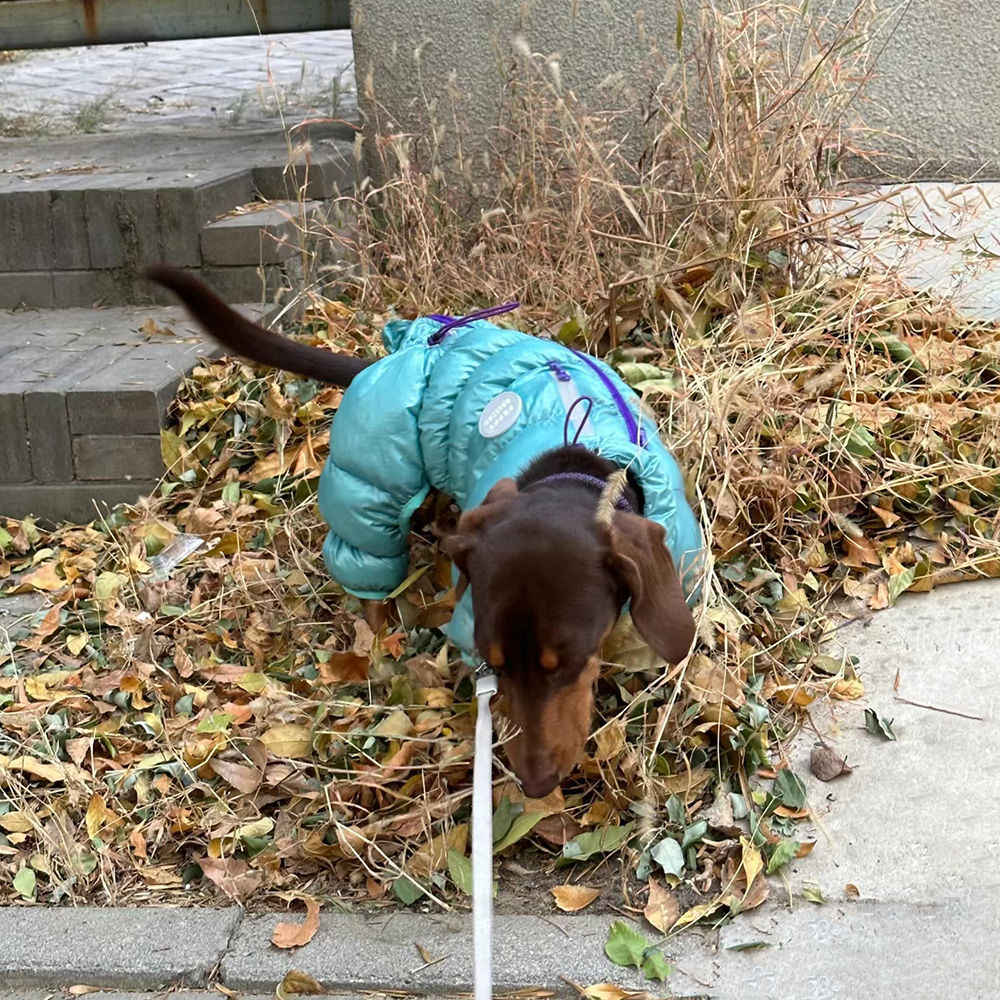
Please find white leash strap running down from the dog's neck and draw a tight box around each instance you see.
[472,663,497,1000]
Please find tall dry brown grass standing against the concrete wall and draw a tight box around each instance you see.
[332,3,888,320]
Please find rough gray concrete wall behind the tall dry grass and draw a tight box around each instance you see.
[351,0,1000,180]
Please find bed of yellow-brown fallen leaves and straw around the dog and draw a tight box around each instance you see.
[0,274,1000,930]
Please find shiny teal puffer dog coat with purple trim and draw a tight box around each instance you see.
[319,318,701,651]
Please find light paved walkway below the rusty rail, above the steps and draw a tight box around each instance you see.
[0,31,356,135]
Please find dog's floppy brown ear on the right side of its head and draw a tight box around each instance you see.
[609,511,695,663]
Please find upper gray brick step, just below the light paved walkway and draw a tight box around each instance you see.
[0,126,355,309]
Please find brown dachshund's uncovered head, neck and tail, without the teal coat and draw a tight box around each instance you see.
[149,267,695,798]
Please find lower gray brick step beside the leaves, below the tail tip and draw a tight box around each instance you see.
[0,304,277,521]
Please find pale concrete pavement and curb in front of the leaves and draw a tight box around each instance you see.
[0,581,1000,1000]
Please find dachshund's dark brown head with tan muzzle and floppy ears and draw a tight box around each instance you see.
[445,479,694,797]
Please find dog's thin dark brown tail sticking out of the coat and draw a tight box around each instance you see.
[146,264,372,386]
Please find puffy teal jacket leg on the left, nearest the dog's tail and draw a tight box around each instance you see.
[319,349,429,599]
